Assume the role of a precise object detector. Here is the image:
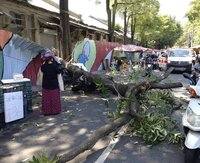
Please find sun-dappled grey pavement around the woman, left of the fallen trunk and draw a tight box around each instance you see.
[0,88,115,163]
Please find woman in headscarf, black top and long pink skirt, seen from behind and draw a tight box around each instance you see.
[41,52,61,115]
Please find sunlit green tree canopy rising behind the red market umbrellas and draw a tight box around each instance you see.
[101,0,182,49]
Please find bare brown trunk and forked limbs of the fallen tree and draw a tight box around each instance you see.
[58,64,182,163]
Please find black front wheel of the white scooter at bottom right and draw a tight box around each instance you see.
[184,146,198,163]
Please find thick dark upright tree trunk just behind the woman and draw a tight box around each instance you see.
[60,0,71,61]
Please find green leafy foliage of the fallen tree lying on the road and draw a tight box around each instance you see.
[109,90,184,145]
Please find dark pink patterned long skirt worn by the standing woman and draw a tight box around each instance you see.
[42,88,61,115]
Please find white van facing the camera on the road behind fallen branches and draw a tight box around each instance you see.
[167,49,193,72]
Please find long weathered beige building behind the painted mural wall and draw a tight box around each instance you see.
[0,0,122,57]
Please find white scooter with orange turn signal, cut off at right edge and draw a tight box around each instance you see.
[182,68,200,163]
